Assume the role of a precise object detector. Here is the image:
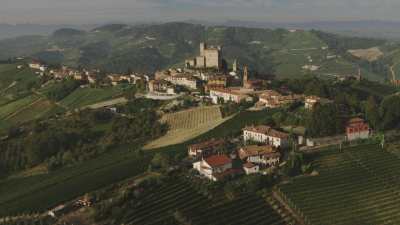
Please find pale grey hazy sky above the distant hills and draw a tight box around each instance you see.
[0,0,400,24]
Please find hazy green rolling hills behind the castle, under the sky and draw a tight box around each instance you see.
[0,22,400,81]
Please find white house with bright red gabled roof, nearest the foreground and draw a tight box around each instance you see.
[193,155,236,181]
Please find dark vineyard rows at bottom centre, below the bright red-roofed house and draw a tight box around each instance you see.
[124,180,285,225]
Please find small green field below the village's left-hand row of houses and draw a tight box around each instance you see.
[60,86,123,109]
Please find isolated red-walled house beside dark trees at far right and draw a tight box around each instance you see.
[346,118,371,141]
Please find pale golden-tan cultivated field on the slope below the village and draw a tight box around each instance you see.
[145,106,229,149]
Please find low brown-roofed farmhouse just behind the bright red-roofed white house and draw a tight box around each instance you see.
[188,139,225,159]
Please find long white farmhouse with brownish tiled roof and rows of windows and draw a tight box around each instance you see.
[243,125,289,148]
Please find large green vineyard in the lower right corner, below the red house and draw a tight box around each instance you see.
[277,145,400,225]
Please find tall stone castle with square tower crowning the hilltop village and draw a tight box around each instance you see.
[185,43,222,69]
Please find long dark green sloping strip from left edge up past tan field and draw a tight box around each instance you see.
[0,111,271,216]
